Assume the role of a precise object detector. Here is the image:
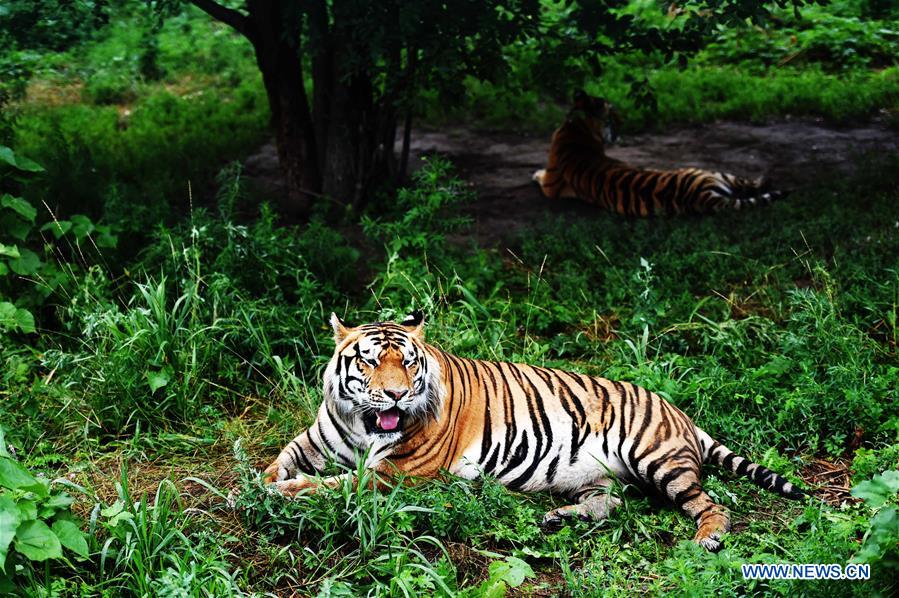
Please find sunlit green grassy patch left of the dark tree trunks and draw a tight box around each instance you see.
[7,6,268,244]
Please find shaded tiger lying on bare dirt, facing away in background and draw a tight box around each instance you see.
[533,91,784,216]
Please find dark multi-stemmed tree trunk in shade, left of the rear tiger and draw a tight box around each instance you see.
[191,0,400,216]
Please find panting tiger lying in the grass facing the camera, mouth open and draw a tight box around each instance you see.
[262,312,805,550]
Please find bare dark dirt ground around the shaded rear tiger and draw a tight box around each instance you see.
[246,119,899,246]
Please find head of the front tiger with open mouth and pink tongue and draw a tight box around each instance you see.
[324,312,441,436]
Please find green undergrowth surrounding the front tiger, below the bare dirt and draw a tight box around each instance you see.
[0,154,899,595]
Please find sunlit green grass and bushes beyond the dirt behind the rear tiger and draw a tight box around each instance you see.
[422,2,899,132]
